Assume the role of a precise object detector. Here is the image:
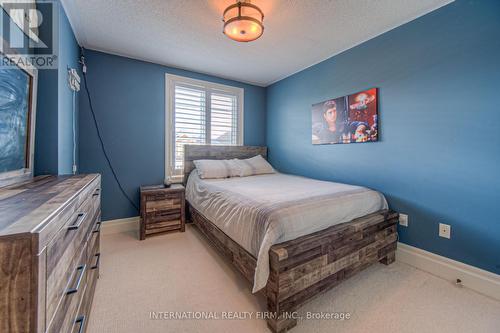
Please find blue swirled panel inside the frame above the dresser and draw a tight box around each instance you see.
[0,59,30,172]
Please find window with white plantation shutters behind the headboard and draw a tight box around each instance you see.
[165,74,243,181]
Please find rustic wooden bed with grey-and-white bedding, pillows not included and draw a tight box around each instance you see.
[184,145,398,332]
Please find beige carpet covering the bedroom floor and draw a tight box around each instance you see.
[87,226,500,333]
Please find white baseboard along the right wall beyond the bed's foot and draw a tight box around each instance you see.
[396,243,500,300]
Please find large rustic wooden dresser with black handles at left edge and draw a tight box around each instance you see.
[0,174,101,333]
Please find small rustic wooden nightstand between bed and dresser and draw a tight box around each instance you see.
[141,184,185,240]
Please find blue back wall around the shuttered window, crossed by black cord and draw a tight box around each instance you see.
[79,51,266,220]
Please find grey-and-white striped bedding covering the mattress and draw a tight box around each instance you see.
[186,170,387,292]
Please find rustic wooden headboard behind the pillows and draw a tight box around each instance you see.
[183,145,267,185]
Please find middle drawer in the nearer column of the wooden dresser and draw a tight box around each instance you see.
[47,247,90,333]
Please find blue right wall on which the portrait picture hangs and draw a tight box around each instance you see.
[267,0,500,273]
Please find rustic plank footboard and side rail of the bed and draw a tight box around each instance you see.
[189,207,398,332]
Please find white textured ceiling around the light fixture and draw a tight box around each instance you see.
[63,0,452,86]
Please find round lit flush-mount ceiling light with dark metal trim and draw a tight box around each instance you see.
[222,1,264,42]
